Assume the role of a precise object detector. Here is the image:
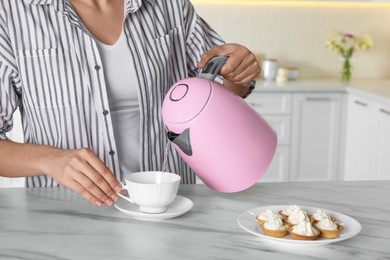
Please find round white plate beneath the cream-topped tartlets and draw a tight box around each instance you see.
[237,205,362,246]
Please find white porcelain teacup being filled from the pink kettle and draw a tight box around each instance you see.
[118,171,181,214]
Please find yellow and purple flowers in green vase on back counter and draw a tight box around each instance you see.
[325,31,373,81]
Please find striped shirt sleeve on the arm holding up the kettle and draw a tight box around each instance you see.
[185,1,225,76]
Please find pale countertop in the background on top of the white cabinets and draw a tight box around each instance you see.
[255,79,390,104]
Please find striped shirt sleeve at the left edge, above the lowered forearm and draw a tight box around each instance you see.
[0,10,21,140]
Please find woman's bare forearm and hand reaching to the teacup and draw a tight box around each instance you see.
[0,140,121,206]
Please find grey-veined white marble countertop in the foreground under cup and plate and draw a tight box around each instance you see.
[0,181,390,260]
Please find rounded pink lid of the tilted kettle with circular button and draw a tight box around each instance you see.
[162,77,212,124]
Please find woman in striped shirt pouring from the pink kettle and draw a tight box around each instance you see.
[0,0,260,206]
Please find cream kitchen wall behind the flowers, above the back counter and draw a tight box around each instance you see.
[192,0,390,79]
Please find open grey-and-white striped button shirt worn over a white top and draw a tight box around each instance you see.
[0,0,223,187]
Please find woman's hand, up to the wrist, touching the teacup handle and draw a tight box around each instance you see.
[41,148,121,207]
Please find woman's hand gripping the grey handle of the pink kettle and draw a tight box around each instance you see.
[198,43,261,90]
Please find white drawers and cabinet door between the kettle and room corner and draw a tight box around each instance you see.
[247,91,344,182]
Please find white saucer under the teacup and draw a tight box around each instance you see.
[114,196,194,220]
